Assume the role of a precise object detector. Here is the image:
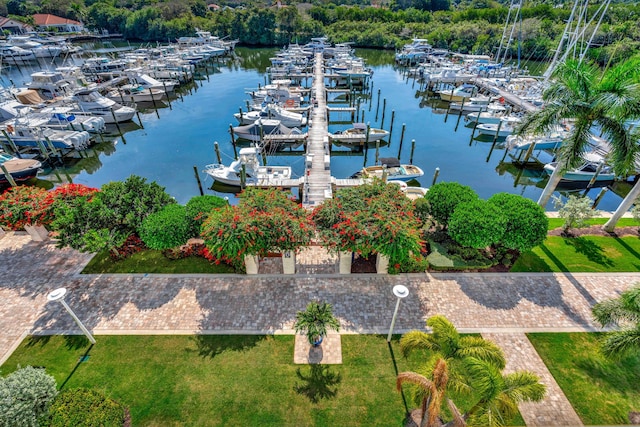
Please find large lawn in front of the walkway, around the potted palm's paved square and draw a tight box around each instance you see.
[2,335,523,426]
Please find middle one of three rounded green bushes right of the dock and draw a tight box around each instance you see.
[448,200,505,249]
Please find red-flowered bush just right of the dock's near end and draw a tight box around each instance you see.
[312,180,422,271]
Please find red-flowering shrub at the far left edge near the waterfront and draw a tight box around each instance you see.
[0,185,50,230]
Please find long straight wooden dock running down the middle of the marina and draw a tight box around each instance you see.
[302,53,333,209]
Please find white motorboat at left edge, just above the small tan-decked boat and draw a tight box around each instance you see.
[0,120,91,150]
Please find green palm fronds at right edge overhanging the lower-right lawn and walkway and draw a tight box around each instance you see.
[591,284,640,358]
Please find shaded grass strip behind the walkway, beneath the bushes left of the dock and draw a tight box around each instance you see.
[82,249,235,274]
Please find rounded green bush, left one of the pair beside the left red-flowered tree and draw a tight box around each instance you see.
[140,204,191,250]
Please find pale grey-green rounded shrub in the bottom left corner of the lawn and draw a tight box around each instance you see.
[0,366,58,427]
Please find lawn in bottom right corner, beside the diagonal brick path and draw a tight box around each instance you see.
[528,333,640,425]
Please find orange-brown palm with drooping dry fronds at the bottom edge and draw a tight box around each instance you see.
[396,359,466,427]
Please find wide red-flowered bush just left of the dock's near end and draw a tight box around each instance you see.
[202,188,314,265]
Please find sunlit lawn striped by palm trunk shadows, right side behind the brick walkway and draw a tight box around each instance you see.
[511,236,640,272]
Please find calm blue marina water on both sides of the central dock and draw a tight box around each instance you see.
[4,49,621,210]
